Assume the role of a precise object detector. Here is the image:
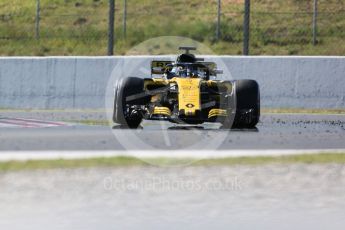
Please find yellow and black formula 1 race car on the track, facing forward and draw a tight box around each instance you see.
[113,47,260,129]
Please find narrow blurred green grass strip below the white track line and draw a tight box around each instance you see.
[0,153,345,172]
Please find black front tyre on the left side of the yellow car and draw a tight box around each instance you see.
[113,77,147,129]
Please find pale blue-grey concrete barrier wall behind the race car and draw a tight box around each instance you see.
[0,56,345,109]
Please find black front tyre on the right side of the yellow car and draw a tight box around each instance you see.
[232,80,260,128]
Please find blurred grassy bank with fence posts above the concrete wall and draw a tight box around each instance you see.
[0,0,345,56]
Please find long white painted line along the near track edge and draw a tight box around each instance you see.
[0,149,345,162]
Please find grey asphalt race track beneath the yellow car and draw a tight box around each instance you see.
[0,112,345,151]
